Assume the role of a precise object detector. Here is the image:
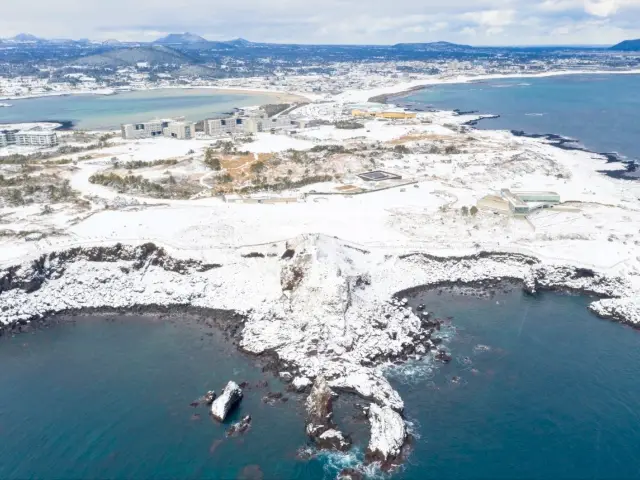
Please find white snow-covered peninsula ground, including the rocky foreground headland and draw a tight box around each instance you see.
[0,82,640,468]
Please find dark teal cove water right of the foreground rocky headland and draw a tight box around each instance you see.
[399,290,640,479]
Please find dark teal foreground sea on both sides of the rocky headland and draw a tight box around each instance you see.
[0,291,640,479]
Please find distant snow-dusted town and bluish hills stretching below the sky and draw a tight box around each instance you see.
[0,34,640,105]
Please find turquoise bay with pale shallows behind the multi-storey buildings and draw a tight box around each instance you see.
[0,88,277,130]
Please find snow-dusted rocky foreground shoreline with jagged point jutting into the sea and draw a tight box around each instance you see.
[0,234,640,467]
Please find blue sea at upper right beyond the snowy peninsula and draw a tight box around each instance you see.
[400,75,640,159]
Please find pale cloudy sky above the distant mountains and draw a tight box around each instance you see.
[0,0,640,45]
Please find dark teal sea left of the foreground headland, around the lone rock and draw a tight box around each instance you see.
[0,318,323,479]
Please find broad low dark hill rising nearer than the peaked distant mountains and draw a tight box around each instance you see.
[73,45,195,68]
